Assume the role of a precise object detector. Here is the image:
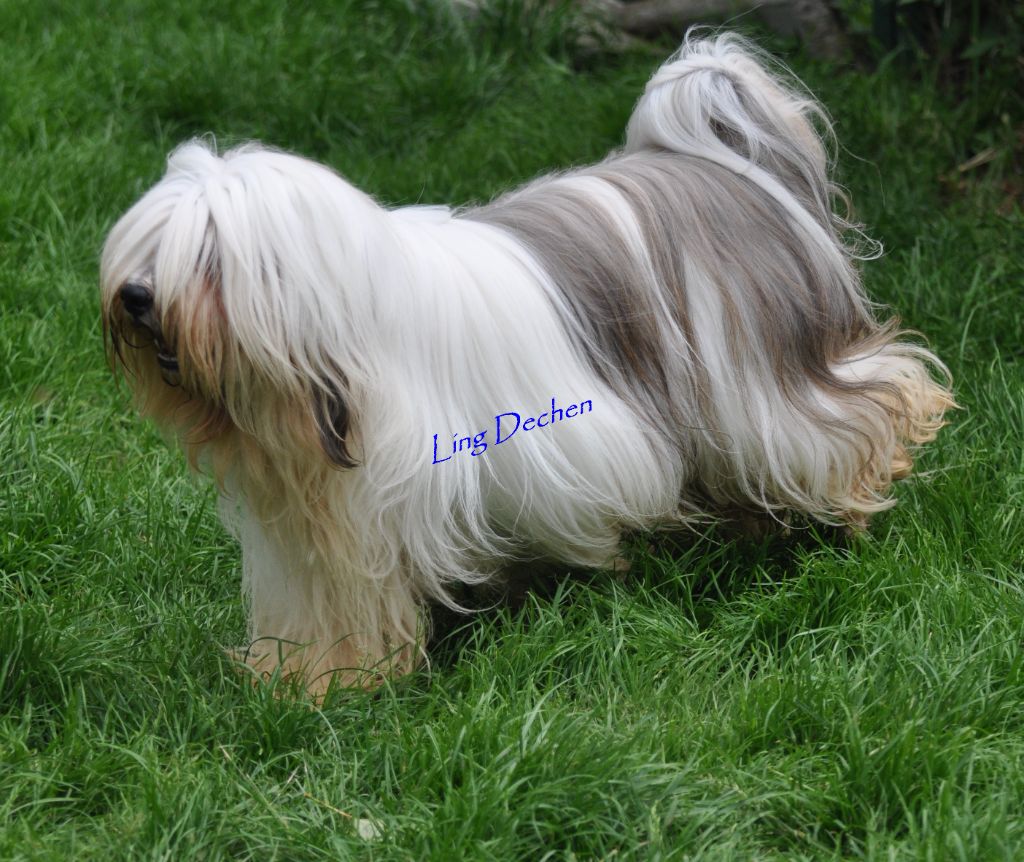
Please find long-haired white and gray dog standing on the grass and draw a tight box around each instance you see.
[101,36,952,693]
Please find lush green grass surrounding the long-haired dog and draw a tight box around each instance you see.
[0,0,1024,862]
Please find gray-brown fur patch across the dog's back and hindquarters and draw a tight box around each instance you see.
[464,152,892,470]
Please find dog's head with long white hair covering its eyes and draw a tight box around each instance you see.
[100,142,376,467]
